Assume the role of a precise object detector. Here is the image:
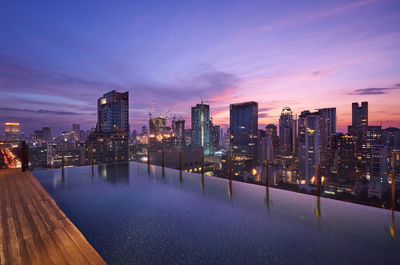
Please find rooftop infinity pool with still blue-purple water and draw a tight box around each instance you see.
[33,162,400,265]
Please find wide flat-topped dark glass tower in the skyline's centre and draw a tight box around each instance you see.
[229,101,258,175]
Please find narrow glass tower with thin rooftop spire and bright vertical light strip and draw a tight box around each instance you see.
[191,101,212,155]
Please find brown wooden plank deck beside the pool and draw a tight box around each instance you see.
[0,169,106,265]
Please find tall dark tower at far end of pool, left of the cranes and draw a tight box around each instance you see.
[86,90,130,163]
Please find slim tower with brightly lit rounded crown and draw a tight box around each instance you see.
[279,107,296,157]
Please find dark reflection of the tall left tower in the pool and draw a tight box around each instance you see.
[97,163,129,185]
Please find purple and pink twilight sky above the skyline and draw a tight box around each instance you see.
[0,0,400,134]
